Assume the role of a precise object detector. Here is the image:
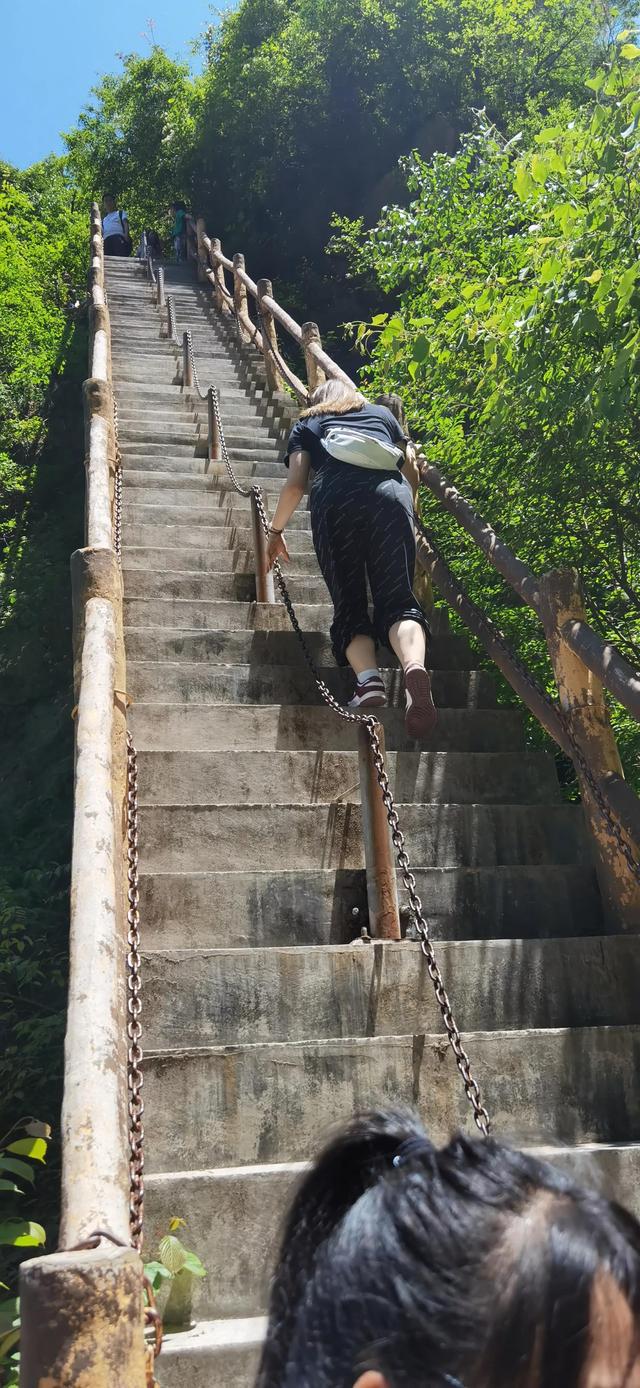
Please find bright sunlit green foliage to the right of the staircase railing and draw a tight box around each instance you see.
[336,32,640,773]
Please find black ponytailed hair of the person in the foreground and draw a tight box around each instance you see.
[255,1112,640,1388]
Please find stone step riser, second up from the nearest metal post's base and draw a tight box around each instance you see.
[140,802,589,873]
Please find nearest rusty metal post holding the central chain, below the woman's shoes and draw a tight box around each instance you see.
[358,725,401,940]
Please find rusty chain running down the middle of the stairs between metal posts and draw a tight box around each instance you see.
[214,389,490,1135]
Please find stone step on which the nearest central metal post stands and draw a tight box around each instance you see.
[143,936,640,1051]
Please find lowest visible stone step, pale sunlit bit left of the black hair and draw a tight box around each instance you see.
[154,1317,267,1388]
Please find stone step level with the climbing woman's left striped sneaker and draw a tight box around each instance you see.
[125,660,496,709]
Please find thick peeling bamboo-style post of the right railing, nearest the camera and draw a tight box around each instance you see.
[540,569,640,926]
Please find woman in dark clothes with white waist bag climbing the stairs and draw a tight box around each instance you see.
[268,380,437,738]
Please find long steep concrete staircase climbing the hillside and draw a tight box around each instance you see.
[107,261,640,1388]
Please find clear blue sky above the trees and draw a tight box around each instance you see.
[0,0,217,168]
